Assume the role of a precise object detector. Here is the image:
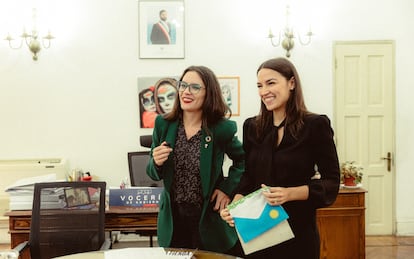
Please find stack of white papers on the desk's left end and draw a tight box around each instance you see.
[5,174,61,210]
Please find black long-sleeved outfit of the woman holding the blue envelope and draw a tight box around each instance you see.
[237,114,340,258]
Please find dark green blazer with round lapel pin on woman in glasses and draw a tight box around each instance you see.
[147,116,244,252]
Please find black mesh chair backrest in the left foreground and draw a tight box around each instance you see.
[29,182,106,259]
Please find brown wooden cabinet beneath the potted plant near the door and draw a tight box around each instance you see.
[317,188,366,259]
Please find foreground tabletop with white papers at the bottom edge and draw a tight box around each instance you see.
[55,247,238,259]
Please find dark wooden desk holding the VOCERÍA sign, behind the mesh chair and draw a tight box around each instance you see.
[5,208,158,259]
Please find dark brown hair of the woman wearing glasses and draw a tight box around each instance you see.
[164,66,231,129]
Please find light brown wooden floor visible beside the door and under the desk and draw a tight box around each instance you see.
[0,236,414,259]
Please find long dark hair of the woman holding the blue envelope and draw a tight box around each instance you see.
[256,58,310,138]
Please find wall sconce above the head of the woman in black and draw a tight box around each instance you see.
[268,6,314,58]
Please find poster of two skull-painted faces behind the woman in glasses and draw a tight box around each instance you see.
[138,76,177,128]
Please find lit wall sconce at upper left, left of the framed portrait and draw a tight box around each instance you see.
[4,8,54,61]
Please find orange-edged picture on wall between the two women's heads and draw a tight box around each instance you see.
[217,76,240,116]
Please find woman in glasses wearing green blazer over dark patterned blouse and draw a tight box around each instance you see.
[147,66,244,255]
